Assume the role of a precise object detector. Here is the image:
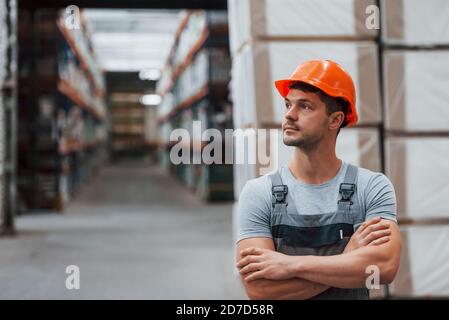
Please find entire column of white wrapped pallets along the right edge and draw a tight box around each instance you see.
[381,0,449,297]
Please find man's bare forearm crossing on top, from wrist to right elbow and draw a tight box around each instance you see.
[295,247,396,288]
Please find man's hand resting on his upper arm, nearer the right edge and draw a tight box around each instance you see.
[343,217,391,253]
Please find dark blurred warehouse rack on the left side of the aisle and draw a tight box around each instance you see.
[18,9,106,211]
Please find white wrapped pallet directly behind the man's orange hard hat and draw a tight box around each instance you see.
[231,41,381,128]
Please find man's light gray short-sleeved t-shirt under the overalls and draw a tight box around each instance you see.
[237,161,396,242]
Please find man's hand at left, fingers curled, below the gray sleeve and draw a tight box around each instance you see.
[237,247,295,282]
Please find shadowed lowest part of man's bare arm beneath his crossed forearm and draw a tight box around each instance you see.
[245,278,329,300]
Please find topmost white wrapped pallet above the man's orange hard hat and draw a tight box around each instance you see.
[228,0,377,54]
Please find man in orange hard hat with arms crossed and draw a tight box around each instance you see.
[237,60,401,299]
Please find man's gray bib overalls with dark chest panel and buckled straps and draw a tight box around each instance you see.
[269,164,369,299]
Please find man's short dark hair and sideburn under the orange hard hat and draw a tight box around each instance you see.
[289,81,349,135]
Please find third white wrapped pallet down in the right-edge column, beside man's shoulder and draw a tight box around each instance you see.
[385,137,449,220]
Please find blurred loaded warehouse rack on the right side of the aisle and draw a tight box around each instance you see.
[157,11,233,201]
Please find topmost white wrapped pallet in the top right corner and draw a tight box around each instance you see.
[381,0,449,46]
